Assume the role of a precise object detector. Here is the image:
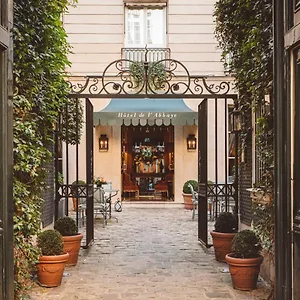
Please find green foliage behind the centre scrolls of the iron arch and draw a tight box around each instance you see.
[129,62,167,90]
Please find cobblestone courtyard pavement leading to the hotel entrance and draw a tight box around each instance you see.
[31,207,268,300]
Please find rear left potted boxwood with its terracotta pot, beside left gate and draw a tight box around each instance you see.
[54,217,83,266]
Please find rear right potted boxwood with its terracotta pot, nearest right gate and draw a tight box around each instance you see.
[210,212,237,262]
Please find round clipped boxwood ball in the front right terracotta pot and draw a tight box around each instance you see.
[231,229,262,258]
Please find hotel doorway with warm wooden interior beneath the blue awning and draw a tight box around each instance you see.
[121,125,174,201]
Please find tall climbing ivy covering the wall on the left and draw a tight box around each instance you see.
[13,0,82,299]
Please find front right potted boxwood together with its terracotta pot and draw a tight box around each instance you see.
[225,229,263,291]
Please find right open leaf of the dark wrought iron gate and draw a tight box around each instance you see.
[198,98,238,247]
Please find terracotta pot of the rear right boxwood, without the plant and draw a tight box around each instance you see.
[210,231,235,262]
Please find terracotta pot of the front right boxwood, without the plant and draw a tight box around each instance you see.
[225,253,263,291]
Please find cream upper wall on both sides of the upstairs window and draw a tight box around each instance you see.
[63,0,224,76]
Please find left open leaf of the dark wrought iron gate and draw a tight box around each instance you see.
[55,98,94,248]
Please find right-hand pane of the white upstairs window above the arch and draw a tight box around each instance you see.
[146,9,165,46]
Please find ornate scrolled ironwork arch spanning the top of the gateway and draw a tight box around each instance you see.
[68,55,235,98]
